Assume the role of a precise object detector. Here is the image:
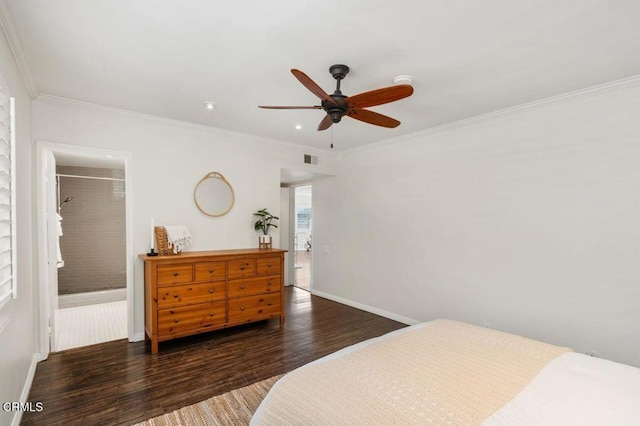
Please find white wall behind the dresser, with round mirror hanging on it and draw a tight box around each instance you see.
[33,98,336,340]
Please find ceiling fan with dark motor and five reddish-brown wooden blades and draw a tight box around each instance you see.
[259,65,413,130]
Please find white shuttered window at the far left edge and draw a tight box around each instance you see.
[0,78,17,312]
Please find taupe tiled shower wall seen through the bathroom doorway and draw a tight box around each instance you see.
[56,166,126,295]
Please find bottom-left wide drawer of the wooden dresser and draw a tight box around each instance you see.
[158,301,226,336]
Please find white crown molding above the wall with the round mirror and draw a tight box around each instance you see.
[35,94,337,157]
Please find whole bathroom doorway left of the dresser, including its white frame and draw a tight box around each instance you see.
[37,142,135,359]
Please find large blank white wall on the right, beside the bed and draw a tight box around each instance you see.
[324,87,640,367]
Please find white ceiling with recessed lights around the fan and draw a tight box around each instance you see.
[5,0,640,150]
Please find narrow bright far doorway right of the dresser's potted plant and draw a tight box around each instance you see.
[292,185,313,291]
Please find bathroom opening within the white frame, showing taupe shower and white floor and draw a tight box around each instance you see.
[52,161,127,351]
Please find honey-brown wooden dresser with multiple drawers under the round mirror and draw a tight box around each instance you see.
[140,249,286,354]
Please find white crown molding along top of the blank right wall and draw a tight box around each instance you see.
[339,75,640,155]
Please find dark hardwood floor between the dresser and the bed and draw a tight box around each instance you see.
[22,287,404,426]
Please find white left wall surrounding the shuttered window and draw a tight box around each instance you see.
[0,21,37,425]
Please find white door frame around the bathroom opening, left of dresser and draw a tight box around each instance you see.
[36,141,135,360]
